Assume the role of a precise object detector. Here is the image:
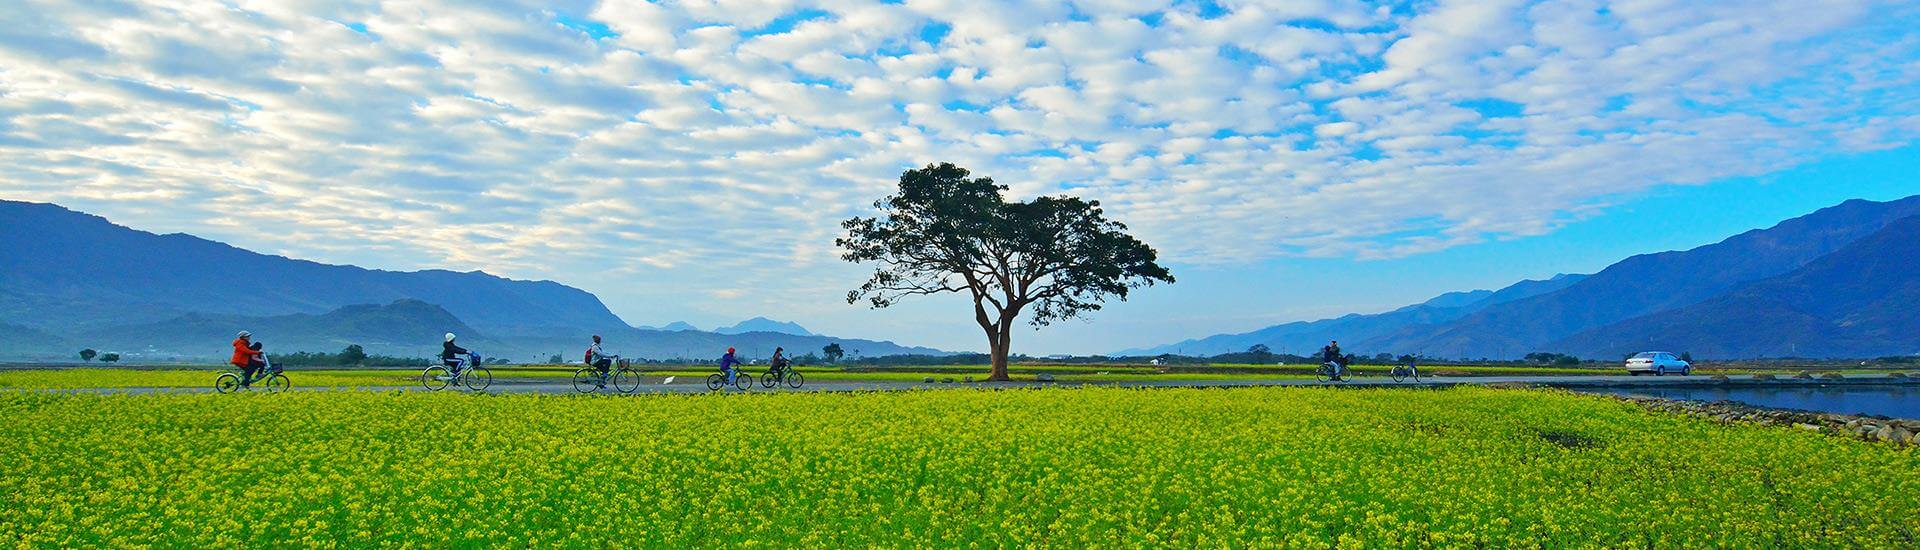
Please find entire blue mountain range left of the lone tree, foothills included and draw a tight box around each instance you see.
[0,200,945,360]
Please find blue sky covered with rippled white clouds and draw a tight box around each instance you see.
[0,0,1920,354]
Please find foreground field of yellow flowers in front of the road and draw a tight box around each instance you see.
[0,388,1920,548]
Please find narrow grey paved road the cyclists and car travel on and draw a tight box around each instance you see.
[37,371,1920,394]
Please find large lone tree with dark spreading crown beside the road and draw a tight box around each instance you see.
[835,163,1173,381]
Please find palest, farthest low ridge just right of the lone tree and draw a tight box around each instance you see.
[1117,275,1586,356]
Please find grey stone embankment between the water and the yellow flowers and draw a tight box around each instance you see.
[1619,396,1920,444]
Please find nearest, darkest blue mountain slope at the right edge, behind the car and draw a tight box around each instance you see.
[1548,215,1920,358]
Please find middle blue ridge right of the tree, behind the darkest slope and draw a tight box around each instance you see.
[1354,196,1920,358]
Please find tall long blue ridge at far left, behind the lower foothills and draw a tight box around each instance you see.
[0,200,626,335]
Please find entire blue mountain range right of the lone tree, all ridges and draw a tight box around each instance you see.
[1123,196,1920,358]
